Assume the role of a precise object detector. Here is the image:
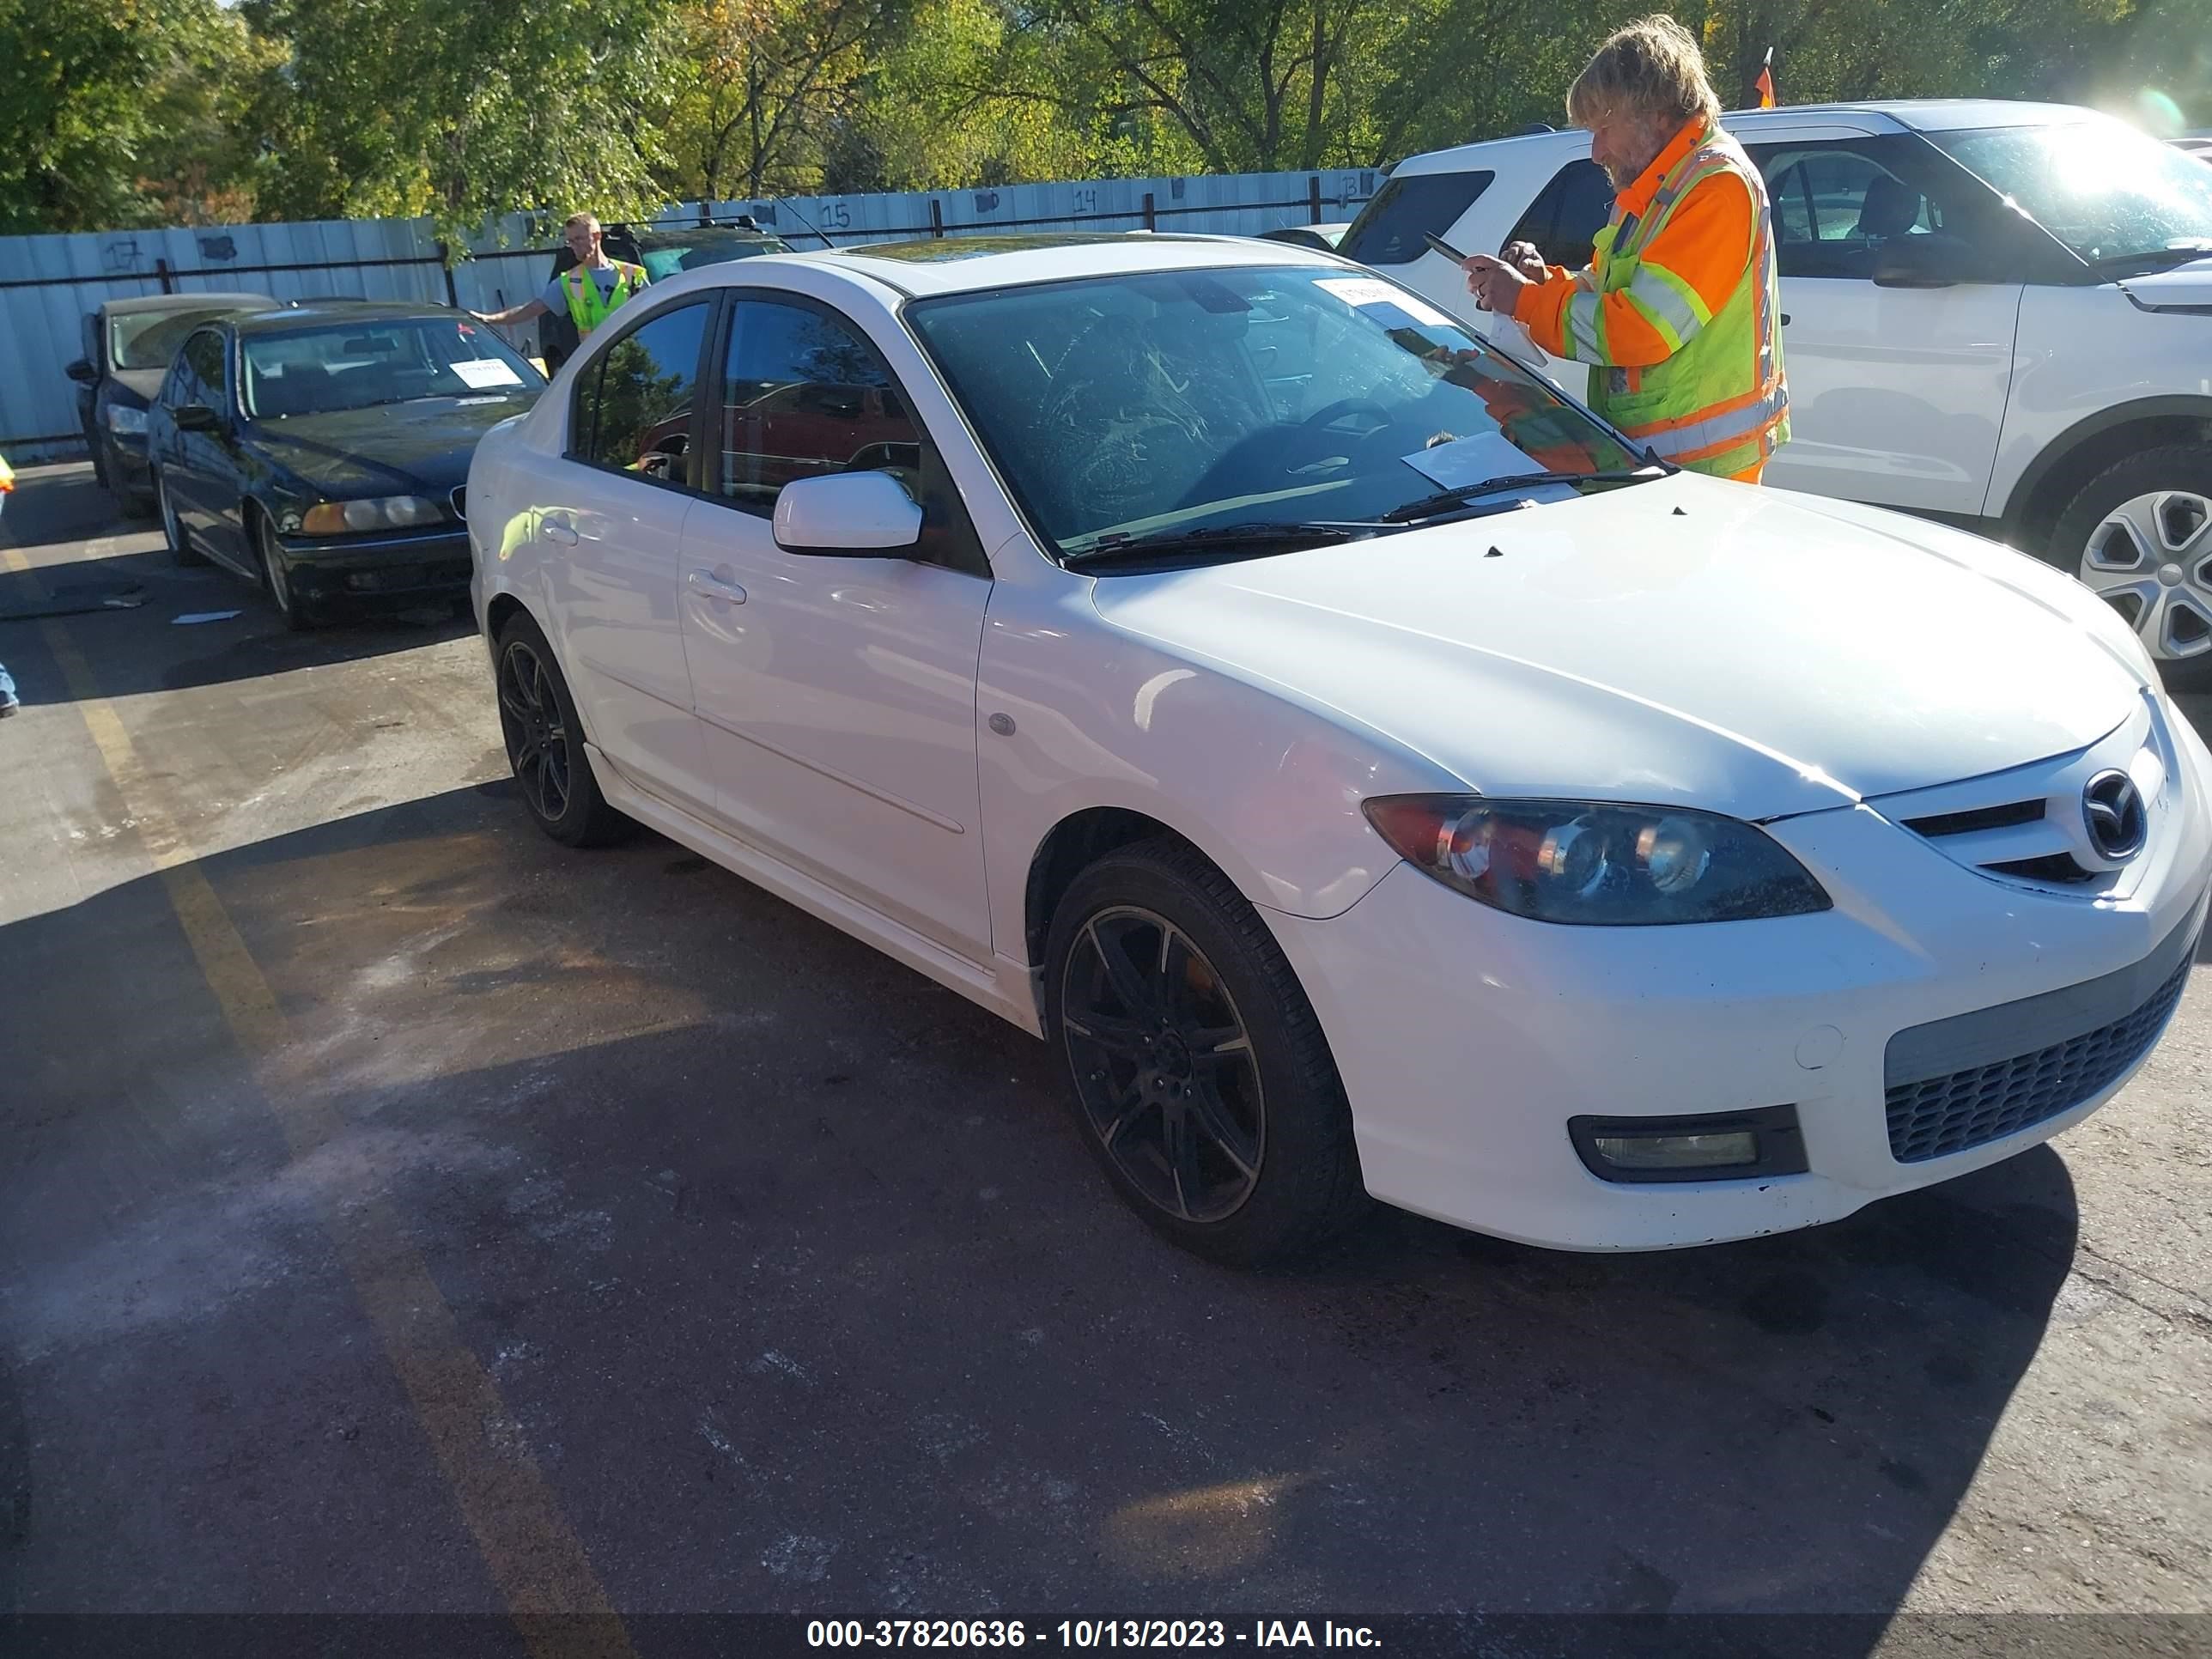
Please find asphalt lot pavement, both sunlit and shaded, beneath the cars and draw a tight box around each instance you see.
[0,467,2212,1652]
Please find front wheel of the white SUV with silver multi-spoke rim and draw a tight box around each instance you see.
[2044,445,2212,679]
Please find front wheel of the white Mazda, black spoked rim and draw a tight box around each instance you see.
[1044,838,1370,1267]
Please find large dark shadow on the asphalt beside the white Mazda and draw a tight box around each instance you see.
[0,790,2077,1652]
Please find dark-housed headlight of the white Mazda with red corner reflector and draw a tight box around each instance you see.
[1363,794,1829,927]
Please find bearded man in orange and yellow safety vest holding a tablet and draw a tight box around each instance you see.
[1467,15,1790,484]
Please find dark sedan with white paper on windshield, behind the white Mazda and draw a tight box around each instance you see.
[146,301,544,629]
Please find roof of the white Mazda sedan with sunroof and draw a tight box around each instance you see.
[809,230,1343,296]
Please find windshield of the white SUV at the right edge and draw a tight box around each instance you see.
[1927,122,2212,265]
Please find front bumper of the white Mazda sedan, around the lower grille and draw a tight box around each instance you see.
[1267,694,2212,1249]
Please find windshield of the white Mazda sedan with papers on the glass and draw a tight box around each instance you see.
[907,265,1637,556]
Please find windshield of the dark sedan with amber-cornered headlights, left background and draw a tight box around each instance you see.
[241,316,544,420]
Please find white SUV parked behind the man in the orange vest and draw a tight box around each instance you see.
[1338,101,2212,668]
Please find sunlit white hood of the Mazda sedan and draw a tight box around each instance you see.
[1095,476,2143,818]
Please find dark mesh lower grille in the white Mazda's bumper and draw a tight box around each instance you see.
[1887,957,2190,1164]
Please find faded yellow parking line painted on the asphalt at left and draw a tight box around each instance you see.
[0,546,635,1659]
